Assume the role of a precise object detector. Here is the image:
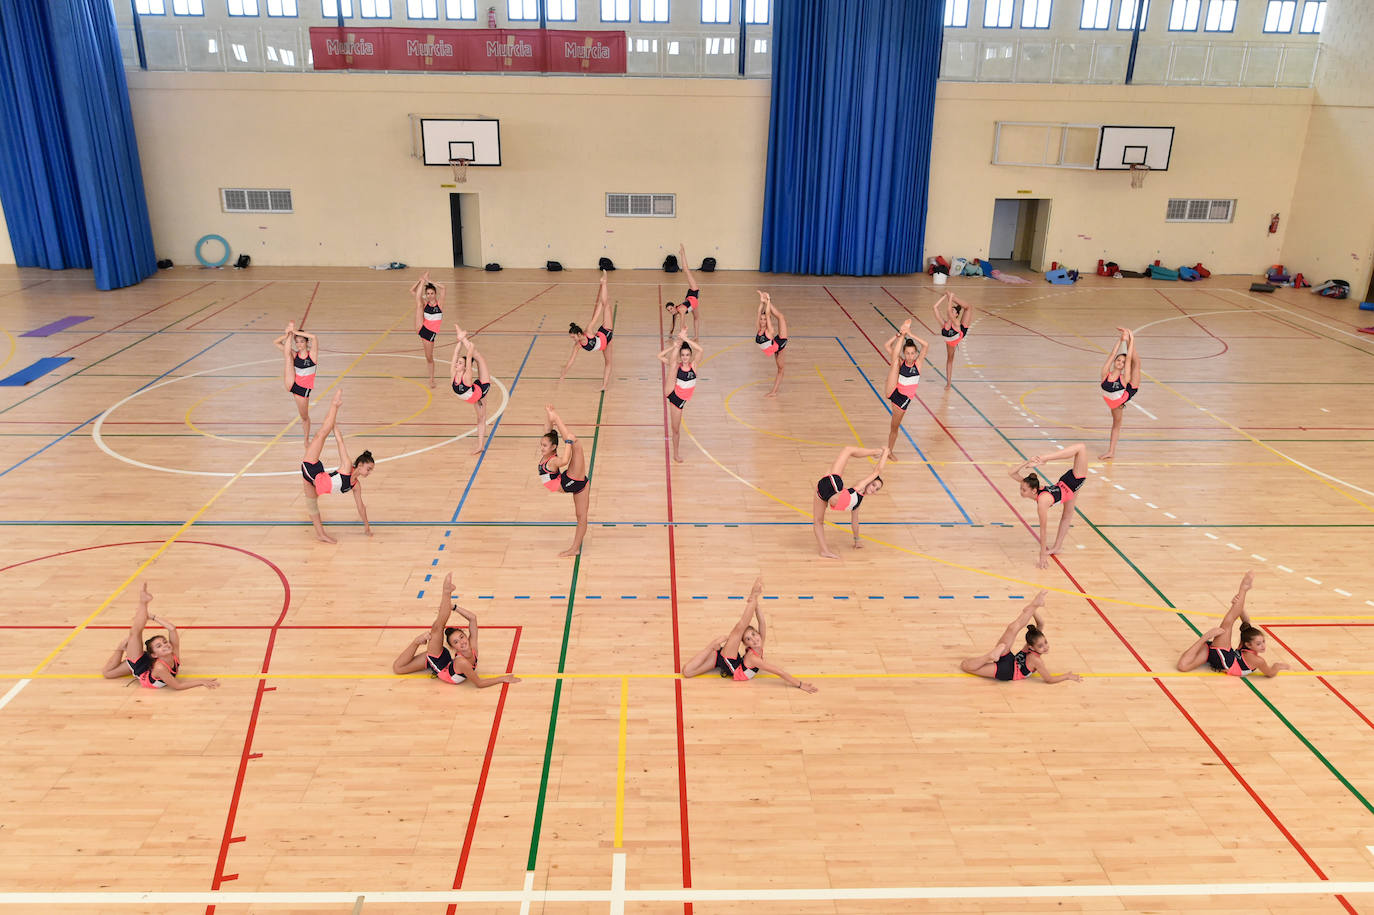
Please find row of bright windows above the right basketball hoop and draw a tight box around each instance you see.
[944,0,1326,34]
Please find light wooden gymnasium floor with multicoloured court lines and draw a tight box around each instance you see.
[0,259,1374,915]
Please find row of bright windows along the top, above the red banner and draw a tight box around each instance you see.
[133,0,769,25]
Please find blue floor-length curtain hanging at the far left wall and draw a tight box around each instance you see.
[0,0,157,289]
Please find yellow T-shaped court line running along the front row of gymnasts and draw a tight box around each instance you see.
[16,669,1374,675]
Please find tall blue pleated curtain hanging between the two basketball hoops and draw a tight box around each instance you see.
[758,0,944,276]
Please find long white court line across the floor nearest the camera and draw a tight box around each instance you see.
[0,875,1374,905]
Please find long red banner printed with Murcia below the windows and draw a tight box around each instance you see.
[311,27,625,73]
